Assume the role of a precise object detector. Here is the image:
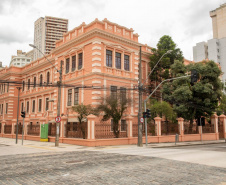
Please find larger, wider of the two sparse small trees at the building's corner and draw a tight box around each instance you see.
[97,93,130,138]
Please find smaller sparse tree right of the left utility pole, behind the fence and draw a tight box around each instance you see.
[72,104,96,139]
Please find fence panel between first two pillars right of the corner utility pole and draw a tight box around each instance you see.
[161,121,179,135]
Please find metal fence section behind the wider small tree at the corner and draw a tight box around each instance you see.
[95,122,127,139]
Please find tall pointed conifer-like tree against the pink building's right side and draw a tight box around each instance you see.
[150,35,183,90]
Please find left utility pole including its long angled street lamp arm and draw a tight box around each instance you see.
[29,44,63,146]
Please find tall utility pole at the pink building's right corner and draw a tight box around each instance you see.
[137,46,143,147]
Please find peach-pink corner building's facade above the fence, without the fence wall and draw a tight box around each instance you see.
[0,19,151,143]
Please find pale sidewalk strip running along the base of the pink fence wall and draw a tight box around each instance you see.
[0,137,226,156]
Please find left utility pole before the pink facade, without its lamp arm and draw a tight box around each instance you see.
[55,60,63,146]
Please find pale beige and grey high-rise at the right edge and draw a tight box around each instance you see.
[193,3,226,82]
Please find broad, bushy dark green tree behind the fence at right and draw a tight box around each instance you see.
[162,61,223,126]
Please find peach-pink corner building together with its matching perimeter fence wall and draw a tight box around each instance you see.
[0,19,226,146]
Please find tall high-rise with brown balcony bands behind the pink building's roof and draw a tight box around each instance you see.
[34,16,68,60]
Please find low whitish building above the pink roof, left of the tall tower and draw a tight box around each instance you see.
[9,50,32,67]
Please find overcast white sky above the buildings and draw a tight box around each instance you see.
[0,0,226,66]
